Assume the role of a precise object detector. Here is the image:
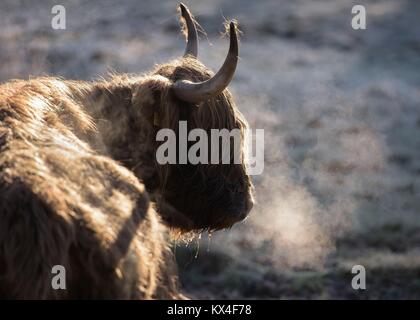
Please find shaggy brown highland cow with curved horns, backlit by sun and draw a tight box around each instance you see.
[0,4,253,299]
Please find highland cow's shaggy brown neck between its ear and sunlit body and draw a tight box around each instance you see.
[69,79,156,188]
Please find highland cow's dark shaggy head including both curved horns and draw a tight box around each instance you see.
[133,4,253,231]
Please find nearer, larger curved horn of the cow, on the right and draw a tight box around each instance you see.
[173,22,239,103]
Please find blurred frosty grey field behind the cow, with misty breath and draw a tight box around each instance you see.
[0,0,420,299]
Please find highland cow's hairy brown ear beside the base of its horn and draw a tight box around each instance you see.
[131,75,171,126]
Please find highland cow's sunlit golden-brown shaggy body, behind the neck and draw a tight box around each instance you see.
[0,80,176,299]
